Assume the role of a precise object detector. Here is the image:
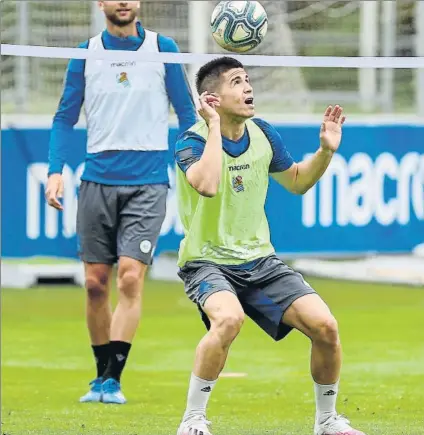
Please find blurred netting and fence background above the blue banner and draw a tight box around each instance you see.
[0,0,420,114]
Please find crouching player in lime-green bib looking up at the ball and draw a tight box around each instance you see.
[176,57,363,435]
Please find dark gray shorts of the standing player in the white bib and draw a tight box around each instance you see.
[77,181,168,265]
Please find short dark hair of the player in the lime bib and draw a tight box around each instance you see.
[196,56,244,95]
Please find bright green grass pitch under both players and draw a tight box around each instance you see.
[1,279,424,435]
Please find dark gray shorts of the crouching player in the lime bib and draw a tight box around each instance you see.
[179,255,316,341]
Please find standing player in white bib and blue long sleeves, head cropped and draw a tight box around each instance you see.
[46,1,196,404]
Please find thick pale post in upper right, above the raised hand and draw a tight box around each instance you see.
[359,0,379,112]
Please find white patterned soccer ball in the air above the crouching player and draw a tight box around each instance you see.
[211,1,268,53]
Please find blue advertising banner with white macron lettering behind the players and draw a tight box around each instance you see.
[1,125,424,258]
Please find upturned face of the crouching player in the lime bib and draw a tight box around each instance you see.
[219,68,255,119]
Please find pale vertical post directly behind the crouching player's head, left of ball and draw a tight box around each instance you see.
[188,1,209,99]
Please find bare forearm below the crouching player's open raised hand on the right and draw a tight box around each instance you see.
[293,148,333,194]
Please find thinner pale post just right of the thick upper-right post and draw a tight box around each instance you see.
[381,1,397,113]
